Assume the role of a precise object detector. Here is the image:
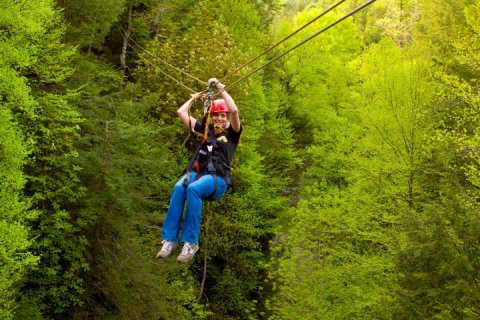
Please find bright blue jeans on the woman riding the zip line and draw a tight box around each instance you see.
[162,172,227,244]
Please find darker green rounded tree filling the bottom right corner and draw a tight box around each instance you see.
[393,200,480,319]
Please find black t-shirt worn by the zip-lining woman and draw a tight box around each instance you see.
[194,121,243,178]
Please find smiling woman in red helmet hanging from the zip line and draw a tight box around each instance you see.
[157,78,242,262]
